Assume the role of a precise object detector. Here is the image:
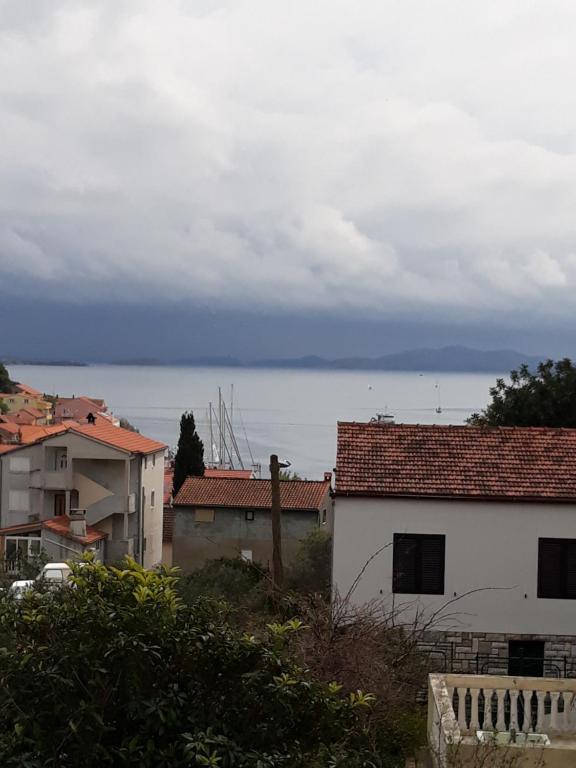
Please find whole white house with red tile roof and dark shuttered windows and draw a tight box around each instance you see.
[333,423,576,676]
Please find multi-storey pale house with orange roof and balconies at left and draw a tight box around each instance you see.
[0,419,166,567]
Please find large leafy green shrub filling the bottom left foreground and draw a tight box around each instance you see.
[0,560,383,768]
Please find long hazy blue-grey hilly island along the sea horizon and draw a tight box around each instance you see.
[111,346,544,373]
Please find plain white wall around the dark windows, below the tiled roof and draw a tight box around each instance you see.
[333,497,576,635]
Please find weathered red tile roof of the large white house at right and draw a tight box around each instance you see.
[336,422,576,501]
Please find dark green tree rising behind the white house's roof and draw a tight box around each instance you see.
[468,358,576,427]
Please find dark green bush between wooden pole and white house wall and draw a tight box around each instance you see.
[286,528,332,599]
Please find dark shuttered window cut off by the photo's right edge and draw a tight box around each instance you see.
[538,539,576,600]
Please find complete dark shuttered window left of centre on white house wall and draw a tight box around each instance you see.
[392,533,446,595]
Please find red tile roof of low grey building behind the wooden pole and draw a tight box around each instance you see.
[174,477,330,510]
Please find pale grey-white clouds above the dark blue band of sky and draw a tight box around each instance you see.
[0,0,576,353]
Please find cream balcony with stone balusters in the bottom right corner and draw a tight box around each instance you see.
[428,674,576,768]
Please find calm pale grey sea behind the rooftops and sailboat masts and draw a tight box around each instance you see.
[9,365,497,478]
